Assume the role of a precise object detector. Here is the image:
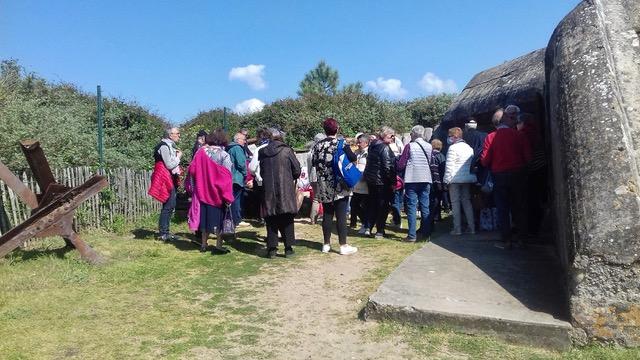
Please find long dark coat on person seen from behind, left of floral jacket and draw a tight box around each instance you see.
[258,140,300,217]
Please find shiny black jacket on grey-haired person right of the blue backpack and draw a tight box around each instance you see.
[363,140,396,186]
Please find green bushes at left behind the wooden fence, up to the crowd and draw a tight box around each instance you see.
[0,60,167,171]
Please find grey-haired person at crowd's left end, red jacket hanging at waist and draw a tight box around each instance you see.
[154,127,182,241]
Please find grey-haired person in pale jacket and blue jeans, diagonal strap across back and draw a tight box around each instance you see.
[398,125,433,242]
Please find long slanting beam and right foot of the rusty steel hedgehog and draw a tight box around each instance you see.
[0,176,109,264]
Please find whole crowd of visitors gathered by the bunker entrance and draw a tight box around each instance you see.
[149,105,545,258]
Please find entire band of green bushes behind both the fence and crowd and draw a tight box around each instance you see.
[0,60,454,171]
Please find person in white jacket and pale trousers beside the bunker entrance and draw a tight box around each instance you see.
[443,127,476,235]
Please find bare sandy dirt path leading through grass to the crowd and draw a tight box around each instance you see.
[190,239,415,359]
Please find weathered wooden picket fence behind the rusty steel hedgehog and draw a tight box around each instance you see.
[0,167,162,236]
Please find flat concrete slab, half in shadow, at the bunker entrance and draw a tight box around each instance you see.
[365,233,571,349]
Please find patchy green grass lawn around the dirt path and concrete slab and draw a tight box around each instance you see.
[0,214,640,359]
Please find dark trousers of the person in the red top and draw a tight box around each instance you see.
[493,171,527,242]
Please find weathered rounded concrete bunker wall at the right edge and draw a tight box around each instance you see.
[545,0,640,346]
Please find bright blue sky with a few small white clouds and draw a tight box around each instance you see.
[0,0,579,123]
